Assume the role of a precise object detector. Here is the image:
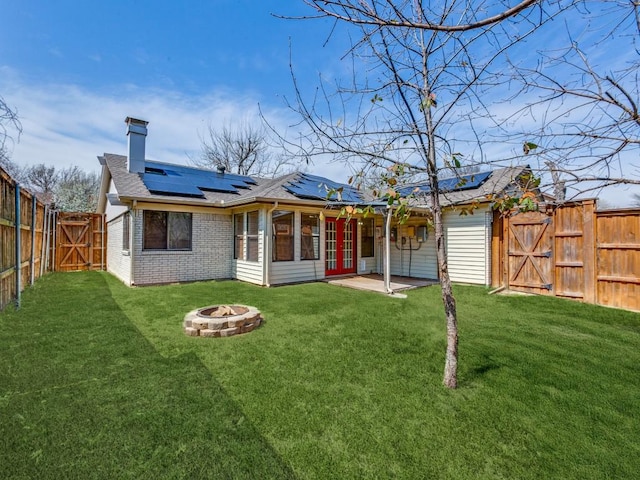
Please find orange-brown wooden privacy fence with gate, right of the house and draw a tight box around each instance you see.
[492,200,640,310]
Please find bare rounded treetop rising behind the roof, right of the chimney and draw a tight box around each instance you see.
[191,122,294,177]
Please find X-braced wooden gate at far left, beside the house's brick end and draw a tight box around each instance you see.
[55,212,107,272]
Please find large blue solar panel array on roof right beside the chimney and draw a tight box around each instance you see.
[142,162,256,197]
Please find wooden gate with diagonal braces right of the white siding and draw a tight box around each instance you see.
[505,212,554,295]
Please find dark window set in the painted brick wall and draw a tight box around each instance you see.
[142,210,191,250]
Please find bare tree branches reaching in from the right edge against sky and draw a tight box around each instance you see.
[497,0,640,200]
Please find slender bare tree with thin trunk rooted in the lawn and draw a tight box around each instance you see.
[290,0,570,388]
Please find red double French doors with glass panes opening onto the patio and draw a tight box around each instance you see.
[325,218,356,275]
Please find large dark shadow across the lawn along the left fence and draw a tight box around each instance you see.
[0,274,295,479]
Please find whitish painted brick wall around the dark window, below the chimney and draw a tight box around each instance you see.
[131,210,233,285]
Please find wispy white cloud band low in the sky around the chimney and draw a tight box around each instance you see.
[0,68,312,177]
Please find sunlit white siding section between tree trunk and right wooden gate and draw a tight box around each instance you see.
[444,206,491,285]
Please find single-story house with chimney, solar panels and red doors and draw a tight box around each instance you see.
[98,117,523,286]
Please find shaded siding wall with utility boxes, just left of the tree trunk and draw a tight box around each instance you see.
[390,225,438,279]
